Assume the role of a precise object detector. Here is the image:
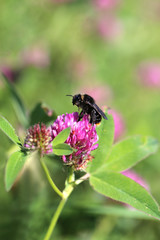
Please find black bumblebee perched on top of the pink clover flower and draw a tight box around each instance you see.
[67,94,107,125]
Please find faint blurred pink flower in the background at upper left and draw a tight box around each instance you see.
[22,47,50,68]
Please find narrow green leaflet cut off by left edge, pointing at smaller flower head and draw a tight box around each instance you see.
[0,116,21,145]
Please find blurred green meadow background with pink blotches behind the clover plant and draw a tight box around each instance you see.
[0,0,160,240]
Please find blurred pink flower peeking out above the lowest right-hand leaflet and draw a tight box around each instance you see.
[121,169,149,190]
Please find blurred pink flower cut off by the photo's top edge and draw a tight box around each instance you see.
[93,0,120,10]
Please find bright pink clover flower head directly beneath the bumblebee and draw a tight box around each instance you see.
[51,112,98,170]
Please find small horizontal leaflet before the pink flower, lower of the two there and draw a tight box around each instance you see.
[53,143,73,156]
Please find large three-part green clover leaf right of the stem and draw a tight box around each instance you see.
[89,117,160,219]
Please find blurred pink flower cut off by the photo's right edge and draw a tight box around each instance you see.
[137,62,160,87]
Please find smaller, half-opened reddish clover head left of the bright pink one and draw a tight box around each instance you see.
[24,123,52,155]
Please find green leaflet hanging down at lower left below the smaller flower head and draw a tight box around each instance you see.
[5,152,26,191]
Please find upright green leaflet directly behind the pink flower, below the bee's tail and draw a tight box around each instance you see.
[87,114,114,173]
